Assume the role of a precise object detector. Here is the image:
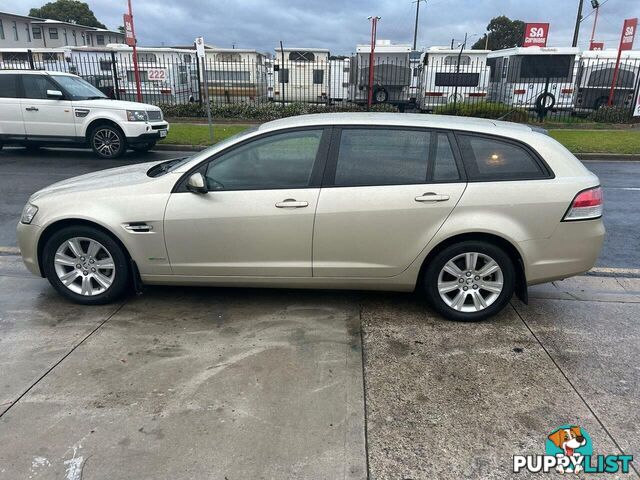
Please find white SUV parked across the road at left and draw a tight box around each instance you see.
[0,70,169,158]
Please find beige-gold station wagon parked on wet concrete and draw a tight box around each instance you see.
[18,113,604,321]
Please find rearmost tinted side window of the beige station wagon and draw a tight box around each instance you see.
[457,135,548,181]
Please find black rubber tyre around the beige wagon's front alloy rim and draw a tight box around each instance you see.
[42,225,131,305]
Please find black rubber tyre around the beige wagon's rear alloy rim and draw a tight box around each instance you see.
[423,240,516,322]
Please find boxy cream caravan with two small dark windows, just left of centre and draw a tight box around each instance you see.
[273,48,329,103]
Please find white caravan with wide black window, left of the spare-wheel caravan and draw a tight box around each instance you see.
[418,47,490,111]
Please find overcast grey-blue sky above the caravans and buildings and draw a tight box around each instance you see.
[0,0,640,54]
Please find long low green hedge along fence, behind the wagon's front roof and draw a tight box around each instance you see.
[160,102,398,122]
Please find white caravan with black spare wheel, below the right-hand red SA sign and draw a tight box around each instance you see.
[487,47,580,112]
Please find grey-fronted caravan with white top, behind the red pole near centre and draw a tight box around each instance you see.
[349,40,412,106]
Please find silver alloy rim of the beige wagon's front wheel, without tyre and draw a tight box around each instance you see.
[53,237,116,296]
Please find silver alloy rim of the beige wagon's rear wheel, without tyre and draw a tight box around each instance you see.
[438,252,504,312]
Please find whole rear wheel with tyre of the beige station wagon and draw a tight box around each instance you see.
[424,240,516,322]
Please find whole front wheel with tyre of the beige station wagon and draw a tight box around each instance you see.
[42,226,130,305]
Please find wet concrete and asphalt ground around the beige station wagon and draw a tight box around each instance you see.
[0,149,640,480]
